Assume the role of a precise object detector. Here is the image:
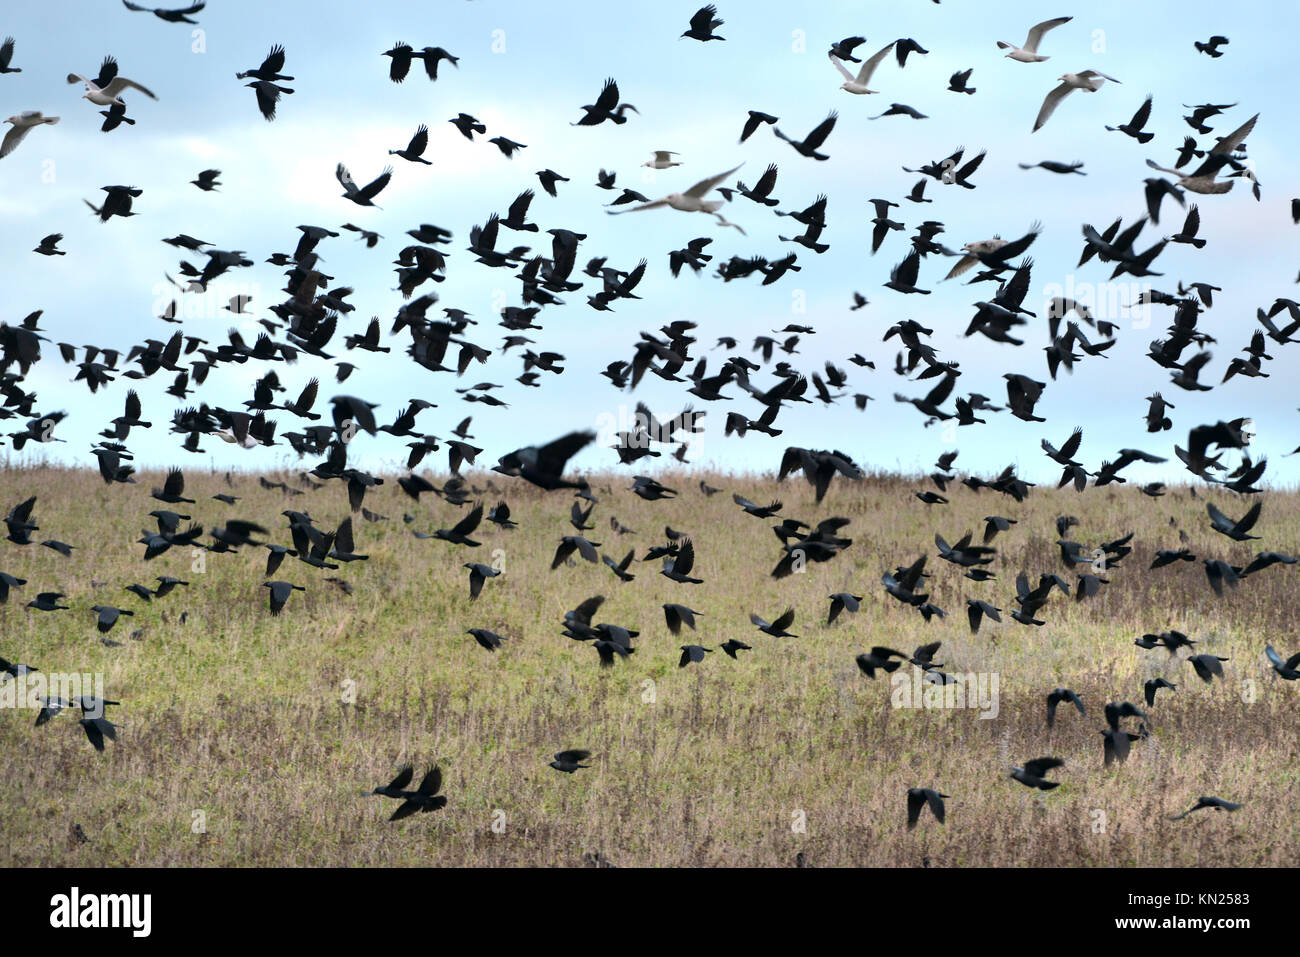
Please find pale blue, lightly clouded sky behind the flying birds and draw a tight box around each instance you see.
[0,0,1300,485]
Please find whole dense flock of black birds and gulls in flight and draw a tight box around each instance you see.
[0,1,1300,827]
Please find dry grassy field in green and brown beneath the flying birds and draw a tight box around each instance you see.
[0,468,1300,867]
